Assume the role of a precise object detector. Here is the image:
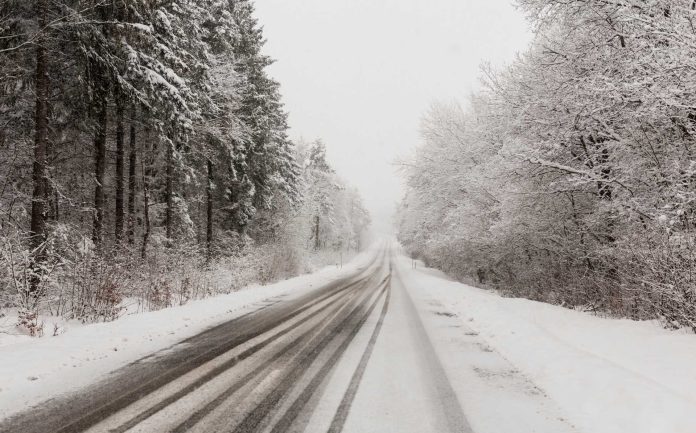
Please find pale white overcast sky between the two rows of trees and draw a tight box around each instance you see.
[256,0,531,235]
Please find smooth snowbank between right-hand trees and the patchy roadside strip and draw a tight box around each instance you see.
[400,258,696,433]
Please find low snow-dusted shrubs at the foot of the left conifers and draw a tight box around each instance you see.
[0,240,355,345]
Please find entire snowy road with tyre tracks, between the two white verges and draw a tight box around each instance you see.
[0,246,472,433]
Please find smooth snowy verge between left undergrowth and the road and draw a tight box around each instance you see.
[0,248,375,419]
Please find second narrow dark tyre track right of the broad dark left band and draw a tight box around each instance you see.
[171,276,370,433]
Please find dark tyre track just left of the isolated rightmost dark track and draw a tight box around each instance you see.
[271,276,390,433]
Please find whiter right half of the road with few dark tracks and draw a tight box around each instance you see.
[304,260,473,433]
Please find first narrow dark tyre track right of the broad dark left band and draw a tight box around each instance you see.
[109,276,370,433]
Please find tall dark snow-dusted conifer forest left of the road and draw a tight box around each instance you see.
[0,0,369,328]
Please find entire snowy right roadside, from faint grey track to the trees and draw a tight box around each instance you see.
[399,253,696,433]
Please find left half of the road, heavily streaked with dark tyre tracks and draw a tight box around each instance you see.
[0,246,389,432]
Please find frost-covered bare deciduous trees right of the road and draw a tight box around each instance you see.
[398,0,696,329]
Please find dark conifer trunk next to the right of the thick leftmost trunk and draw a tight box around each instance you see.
[92,65,109,246]
